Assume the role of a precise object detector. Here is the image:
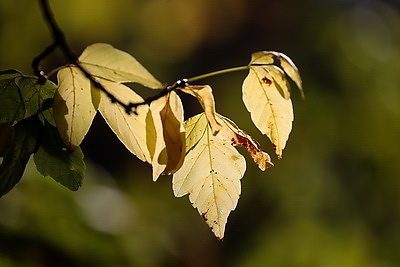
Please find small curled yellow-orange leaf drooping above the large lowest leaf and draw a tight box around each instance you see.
[181,85,221,135]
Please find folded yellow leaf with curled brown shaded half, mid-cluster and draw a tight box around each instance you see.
[150,91,185,181]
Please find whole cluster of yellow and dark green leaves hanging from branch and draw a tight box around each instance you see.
[0,44,302,239]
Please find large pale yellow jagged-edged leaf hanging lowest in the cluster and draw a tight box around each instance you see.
[172,113,246,239]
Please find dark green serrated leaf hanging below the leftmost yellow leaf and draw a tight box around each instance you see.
[33,124,85,191]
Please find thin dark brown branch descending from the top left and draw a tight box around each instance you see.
[32,0,177,114]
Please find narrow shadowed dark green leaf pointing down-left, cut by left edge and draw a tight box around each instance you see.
[0,116,42,197]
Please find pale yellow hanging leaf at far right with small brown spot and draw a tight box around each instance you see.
[242,66,293,157]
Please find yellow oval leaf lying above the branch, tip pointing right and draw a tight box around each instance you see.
[79,43,162,89]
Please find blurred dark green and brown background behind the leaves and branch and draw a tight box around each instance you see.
[0,0,400,267]
